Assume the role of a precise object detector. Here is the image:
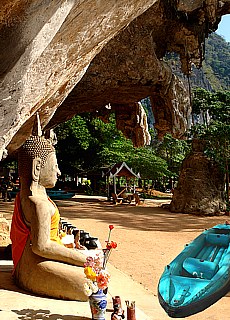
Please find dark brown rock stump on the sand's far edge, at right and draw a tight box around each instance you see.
[170,140,226,216]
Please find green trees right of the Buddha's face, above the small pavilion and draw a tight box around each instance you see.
[56,114,175,179]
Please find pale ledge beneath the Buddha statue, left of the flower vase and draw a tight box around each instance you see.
[0,268,91,320]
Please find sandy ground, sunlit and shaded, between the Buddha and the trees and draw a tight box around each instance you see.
[0,196,230,320]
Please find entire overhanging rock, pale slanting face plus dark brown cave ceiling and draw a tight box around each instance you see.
[0,0,230,156]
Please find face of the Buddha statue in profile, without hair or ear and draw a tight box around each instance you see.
[39,152,61,188]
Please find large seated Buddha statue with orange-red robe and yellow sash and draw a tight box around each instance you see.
[11,116,90,301]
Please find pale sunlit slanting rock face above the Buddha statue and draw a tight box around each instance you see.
[0,0,156,159]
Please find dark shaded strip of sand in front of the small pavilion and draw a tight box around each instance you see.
[56,199,229,233]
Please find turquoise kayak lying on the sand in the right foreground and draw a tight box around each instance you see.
[158,223,230,318]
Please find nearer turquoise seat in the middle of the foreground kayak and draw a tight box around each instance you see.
[183,257,218,280]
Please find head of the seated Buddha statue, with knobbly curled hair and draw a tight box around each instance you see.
[18,135,61,188]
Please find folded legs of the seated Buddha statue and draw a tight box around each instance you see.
[14,246,88,301]
